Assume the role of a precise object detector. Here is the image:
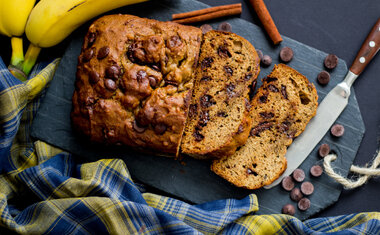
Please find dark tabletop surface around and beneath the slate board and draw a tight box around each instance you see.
[0,0,380,217]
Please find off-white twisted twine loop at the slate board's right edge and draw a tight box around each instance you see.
[323,151,380,189]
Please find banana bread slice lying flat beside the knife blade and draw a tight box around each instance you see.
[211,64,318,189]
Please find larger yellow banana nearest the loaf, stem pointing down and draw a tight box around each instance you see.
[23,0,147,74]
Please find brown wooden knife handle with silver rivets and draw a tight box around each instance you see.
[350,18,380,75]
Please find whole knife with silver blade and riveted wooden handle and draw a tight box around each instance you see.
[264,18,380,189]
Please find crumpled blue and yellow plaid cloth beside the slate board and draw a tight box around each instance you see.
[0,58,380,234]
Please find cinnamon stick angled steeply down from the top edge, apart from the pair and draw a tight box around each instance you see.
[249,0,282,45]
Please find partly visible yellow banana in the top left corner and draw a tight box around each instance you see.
[0,0,36,80]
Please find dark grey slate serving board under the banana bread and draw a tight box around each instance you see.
[32,0,364,220]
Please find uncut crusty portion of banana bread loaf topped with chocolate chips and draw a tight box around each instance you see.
[71,15,202,155]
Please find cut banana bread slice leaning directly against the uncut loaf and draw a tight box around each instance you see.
[181,31,260,159]
